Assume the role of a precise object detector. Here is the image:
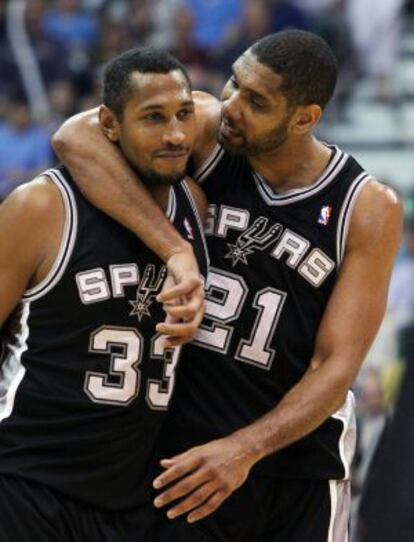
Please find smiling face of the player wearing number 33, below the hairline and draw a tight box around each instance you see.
[118,70,195,184]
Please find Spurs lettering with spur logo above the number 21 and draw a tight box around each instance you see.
[206,205,335,288]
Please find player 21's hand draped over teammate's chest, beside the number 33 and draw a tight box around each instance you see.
[157,250,204,347]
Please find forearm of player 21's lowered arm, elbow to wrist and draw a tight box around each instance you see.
[231,364,352,463]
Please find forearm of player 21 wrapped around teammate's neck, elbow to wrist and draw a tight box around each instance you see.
[52,115,192,261]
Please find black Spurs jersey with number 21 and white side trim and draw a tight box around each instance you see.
[164,146,368,479]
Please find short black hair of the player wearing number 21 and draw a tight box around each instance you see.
[250,30,338,108]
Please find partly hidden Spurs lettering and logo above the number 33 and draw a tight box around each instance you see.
[76,263,167,314]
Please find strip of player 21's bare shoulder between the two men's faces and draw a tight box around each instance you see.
[193,91,221,168]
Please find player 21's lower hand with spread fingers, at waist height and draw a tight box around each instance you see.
[154,435,257,523]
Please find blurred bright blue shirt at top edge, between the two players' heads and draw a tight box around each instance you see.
[185,0,245,50]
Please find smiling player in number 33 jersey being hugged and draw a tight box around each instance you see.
[0,49,207,542]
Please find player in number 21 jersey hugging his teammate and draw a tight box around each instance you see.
[53,31,402,542]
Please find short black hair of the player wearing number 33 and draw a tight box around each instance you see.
[102,47,191,119]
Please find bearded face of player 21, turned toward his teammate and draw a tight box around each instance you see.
[217,51,293,156]
